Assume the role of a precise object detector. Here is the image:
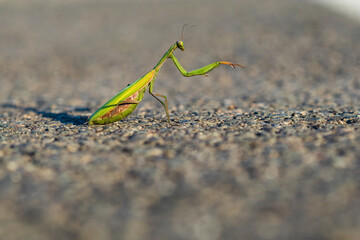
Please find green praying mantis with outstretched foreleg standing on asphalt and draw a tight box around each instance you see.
[88,24,244,125]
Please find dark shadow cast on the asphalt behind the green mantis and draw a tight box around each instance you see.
[1,103,90,125]
